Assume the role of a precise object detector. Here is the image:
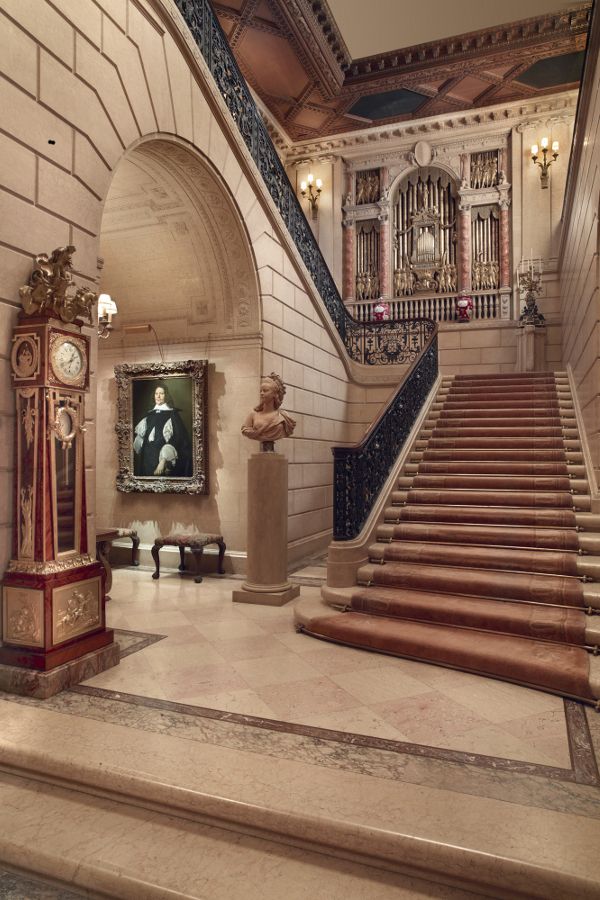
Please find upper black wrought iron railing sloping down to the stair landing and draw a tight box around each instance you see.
[175,0,436,365]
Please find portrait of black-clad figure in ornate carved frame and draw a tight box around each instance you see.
[115,359,208,494]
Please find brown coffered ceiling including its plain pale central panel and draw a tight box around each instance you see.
[213,0,592,141]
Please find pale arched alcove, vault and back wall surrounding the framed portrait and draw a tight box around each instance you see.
[96,136,260,562]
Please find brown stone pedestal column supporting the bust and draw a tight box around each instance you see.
[232,452,300,606]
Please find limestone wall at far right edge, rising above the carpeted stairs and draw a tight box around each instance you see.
[560,8,600,492]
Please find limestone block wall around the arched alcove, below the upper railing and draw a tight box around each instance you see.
[0,0,399,568]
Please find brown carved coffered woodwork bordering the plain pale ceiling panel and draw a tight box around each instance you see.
[213,0,592,141]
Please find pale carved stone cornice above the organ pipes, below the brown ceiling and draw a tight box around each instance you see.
[285,91,577,167]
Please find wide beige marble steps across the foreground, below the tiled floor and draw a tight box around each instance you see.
[0,700,564,900]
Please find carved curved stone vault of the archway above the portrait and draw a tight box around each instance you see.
[100,139,260,340]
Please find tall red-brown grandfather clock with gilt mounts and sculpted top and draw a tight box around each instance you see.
[0,246,119,696]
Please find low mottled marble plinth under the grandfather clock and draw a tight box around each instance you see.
[0,641,120,700]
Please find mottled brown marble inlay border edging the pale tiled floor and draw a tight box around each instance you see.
[0,630,600,820]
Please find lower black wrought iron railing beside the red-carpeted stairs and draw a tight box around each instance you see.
[333,322,438,541]
